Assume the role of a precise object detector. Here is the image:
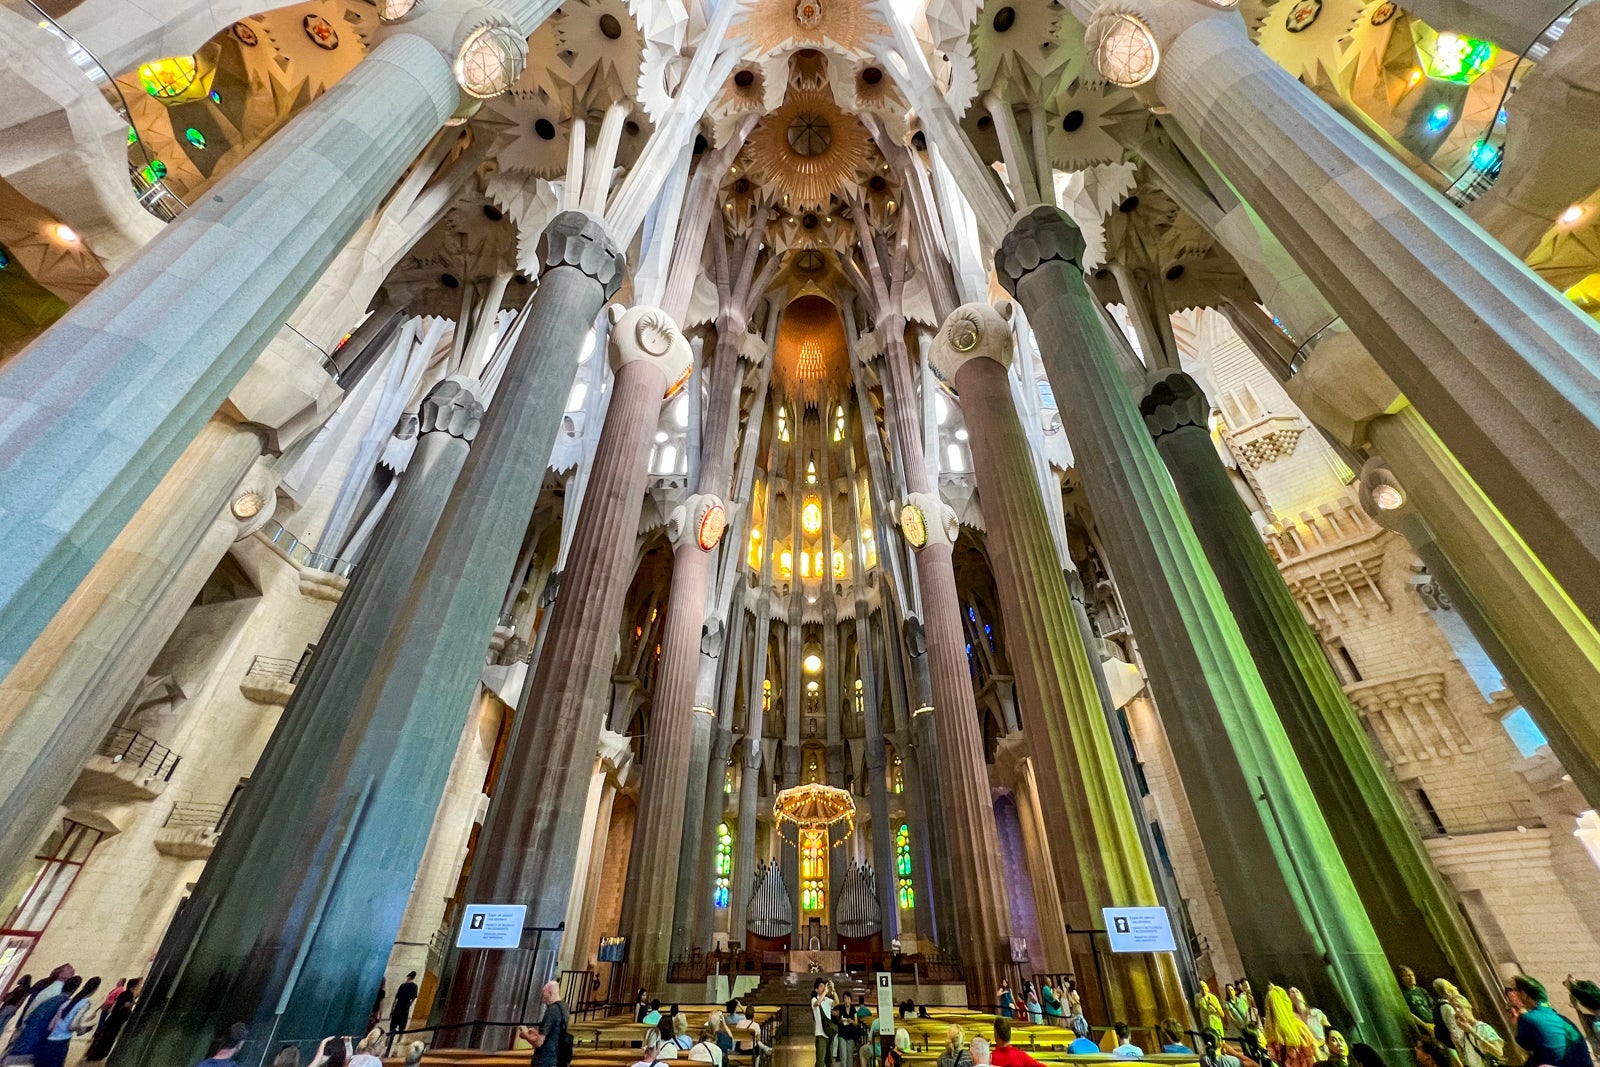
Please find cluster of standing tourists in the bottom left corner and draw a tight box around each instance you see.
[0,963,139,1067]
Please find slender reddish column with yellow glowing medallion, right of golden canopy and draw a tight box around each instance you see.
[878,315,1011,1005]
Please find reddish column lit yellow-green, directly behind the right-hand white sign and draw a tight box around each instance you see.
[933,304,1186,1024]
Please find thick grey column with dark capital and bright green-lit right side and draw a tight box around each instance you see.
[995,208,1405,1051]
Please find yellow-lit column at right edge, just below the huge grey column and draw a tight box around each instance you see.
[1288,339,1600,803]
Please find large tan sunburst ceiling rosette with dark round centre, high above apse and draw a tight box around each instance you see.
[749,90,870,211]
